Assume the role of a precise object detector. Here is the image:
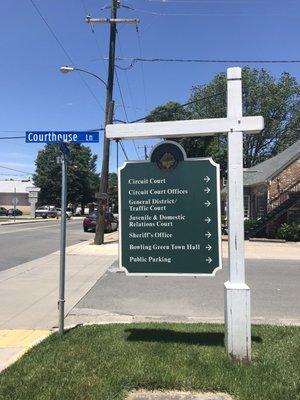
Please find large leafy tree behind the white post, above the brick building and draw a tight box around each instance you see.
[147,67,300,174]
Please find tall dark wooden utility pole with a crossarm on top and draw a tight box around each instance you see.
[86,0,139,245]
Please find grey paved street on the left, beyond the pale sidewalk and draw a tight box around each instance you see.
[0,219,93,271]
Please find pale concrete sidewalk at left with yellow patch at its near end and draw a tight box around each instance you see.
[0,232,117,370]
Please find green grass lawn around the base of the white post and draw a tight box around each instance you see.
[0,323,300,400]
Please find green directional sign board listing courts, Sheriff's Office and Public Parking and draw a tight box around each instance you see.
[119,141,221,275]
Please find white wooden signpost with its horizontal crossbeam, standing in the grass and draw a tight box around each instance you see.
[106,68,264,362]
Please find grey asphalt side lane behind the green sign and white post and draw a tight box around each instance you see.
[74,259,300,323]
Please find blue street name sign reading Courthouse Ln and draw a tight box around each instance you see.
[26,131,99,143]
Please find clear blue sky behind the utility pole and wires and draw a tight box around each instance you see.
[0,0,300,179]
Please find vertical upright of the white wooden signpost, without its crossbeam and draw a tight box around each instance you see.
[224,68,251,362]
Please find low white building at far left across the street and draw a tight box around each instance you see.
[0,180,38,214]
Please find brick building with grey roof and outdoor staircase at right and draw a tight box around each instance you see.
[222,140,300,237]
